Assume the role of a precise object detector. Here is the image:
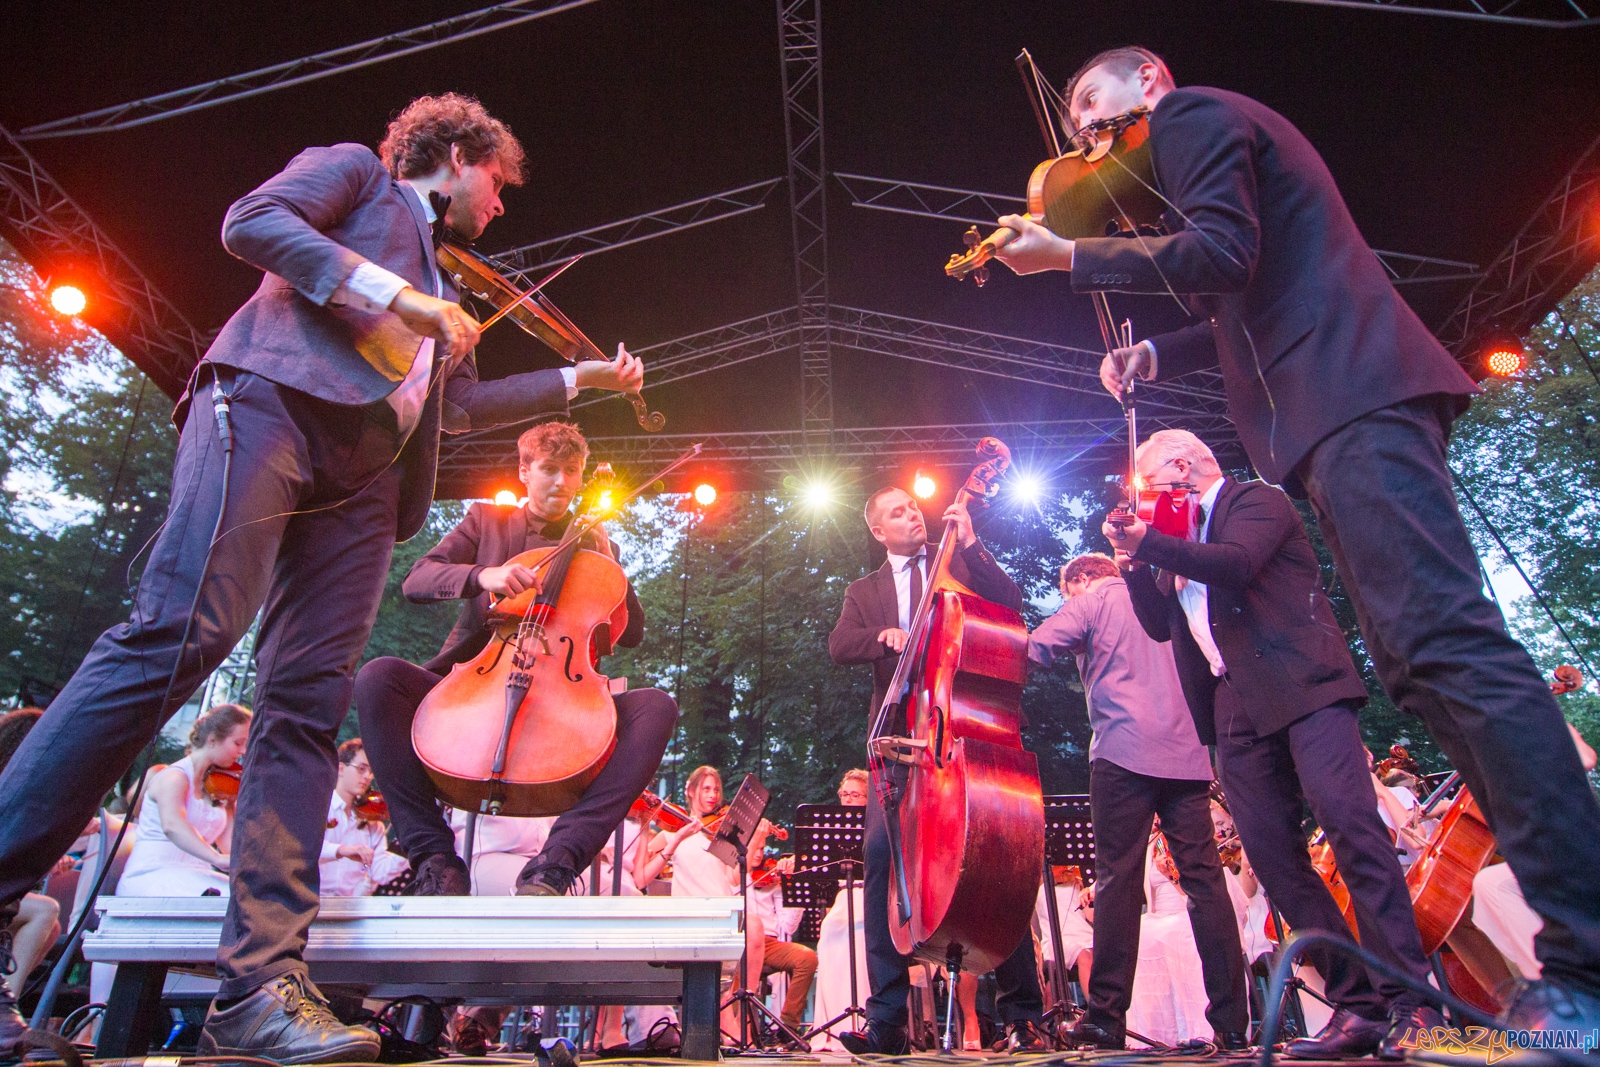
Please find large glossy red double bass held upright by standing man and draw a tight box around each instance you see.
[869,437,1045,1004]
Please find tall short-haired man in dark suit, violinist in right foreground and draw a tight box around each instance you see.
[998,48,1600,1029]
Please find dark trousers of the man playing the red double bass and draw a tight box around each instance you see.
[862,768,1045,1027]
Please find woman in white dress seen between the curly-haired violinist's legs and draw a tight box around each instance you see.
[117,704,250,896]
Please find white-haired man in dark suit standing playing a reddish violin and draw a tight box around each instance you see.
[1096,430,1443,1059]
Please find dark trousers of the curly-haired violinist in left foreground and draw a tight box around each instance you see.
[0,373,400,998]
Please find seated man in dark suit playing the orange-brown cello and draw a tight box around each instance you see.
[355,422,678,896]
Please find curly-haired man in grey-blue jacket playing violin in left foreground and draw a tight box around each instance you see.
[0,93,643,1064]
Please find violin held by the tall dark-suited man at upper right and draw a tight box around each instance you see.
[944,107,1166,285]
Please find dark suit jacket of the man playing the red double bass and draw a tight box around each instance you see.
[827,541,1022,712]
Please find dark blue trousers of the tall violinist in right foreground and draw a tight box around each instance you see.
[1298,397,1600,993]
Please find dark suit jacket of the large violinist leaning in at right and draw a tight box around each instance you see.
[1072,88,1477,493]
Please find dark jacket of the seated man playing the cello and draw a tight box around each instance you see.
[400,504,645,673]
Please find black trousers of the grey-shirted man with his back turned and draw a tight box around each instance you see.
[1088,760,1250,1033]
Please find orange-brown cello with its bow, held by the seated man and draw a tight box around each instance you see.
[411,445,701,816]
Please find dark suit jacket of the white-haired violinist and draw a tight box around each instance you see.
[1128,478,1366,745]
